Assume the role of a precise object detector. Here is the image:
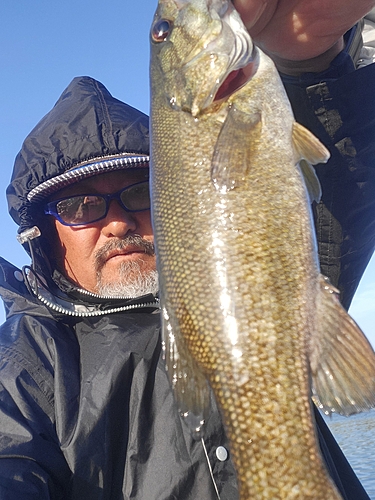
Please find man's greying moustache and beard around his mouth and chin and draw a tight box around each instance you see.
[95,235,159,298]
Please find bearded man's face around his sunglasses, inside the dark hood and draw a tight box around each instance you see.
[48,168,156,295]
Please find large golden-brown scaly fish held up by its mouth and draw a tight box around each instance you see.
[150,0,375,500]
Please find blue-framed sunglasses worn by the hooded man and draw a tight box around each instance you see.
[44,181,151,226]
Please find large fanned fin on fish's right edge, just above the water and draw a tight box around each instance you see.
[310,276,375,416]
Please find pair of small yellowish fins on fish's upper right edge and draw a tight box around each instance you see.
[292,122,330,202]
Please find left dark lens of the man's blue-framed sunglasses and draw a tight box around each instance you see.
[56,195,106,224]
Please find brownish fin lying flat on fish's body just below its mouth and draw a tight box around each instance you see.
[211,105,261,191]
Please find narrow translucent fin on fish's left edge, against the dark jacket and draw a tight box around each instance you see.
[162,298,210,438]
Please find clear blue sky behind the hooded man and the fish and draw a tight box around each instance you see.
[0,0,375,347]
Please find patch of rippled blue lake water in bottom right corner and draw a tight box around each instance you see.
[324,410,375,500]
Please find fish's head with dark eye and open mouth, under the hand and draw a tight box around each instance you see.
[151,0,255,117]
